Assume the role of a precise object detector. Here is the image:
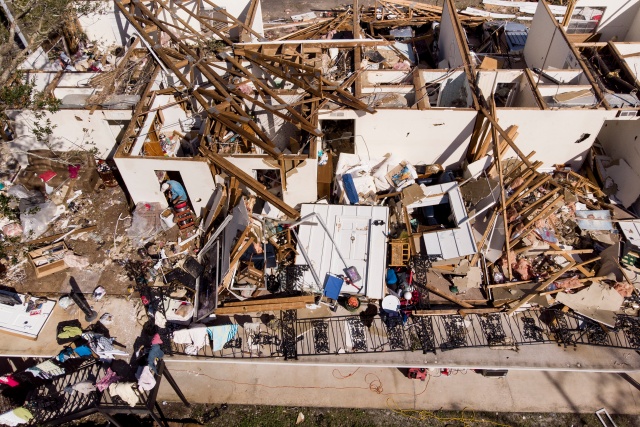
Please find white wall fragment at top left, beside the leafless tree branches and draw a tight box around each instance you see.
[78,0,137,47]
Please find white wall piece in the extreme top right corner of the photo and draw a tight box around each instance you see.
[576,0,640,42]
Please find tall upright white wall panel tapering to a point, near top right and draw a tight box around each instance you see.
[524,2,580,70]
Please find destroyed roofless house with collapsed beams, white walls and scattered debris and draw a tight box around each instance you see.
[0,0,640,422]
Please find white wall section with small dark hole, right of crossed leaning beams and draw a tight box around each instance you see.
[497,109,616,169]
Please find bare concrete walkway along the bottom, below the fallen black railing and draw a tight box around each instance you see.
[158,359,640,414]
